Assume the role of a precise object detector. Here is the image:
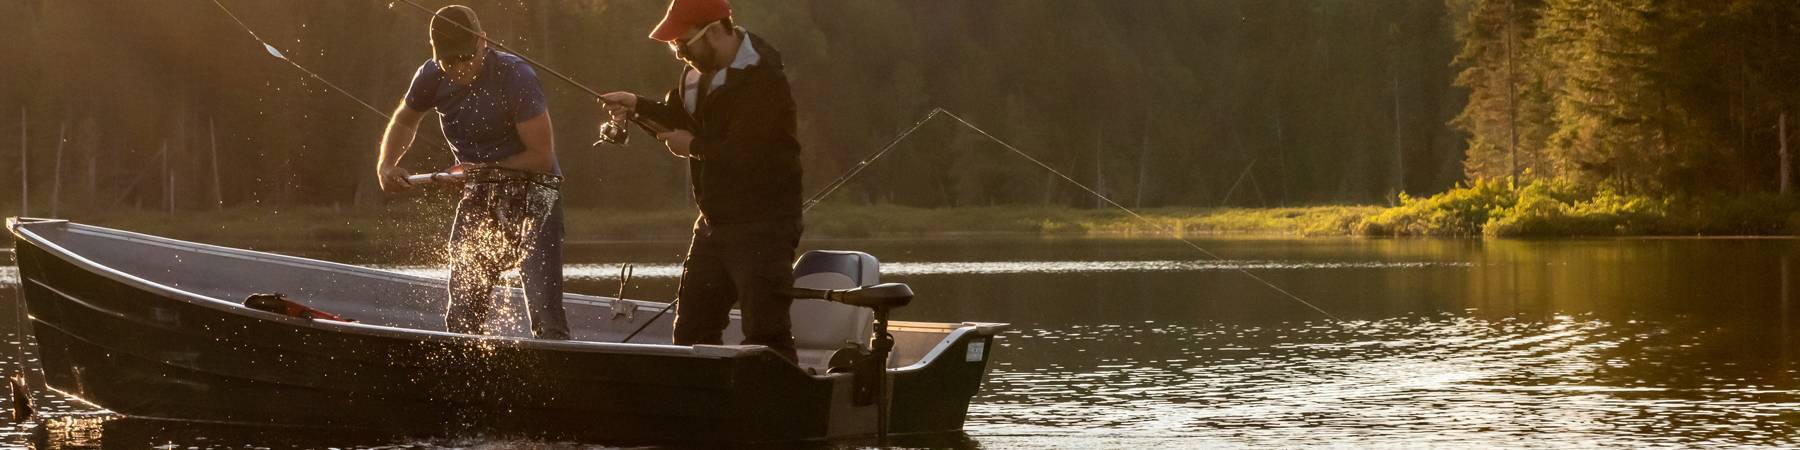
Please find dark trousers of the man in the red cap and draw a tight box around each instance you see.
[675,218,801,362]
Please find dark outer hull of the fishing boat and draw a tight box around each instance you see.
[14,219,994,445]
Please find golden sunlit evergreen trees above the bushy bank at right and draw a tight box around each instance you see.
[1451,0,1800,194]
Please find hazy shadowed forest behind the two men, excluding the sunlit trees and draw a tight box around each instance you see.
[0,0,1465,211]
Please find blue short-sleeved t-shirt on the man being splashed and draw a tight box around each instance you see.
[407,50,560,171]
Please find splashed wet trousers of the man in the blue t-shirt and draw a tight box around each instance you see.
[445,182,569,338]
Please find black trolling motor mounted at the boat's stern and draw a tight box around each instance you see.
[785,283,913,446]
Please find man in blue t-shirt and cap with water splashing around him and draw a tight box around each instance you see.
[374,5,569,338]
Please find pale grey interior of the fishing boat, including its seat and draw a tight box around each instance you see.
[18,220,961,374]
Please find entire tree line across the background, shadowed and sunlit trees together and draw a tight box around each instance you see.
[14,0,1771,217]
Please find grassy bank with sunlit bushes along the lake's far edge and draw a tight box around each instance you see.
[42,182,1800,243]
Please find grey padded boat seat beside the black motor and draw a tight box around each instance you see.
[788,250,880,351]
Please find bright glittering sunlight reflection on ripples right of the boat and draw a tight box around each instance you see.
[968,317,1800,445]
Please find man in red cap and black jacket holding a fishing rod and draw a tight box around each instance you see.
[603,0,801,360]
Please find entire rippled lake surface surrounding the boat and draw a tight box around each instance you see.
[0,239,1800,448]
